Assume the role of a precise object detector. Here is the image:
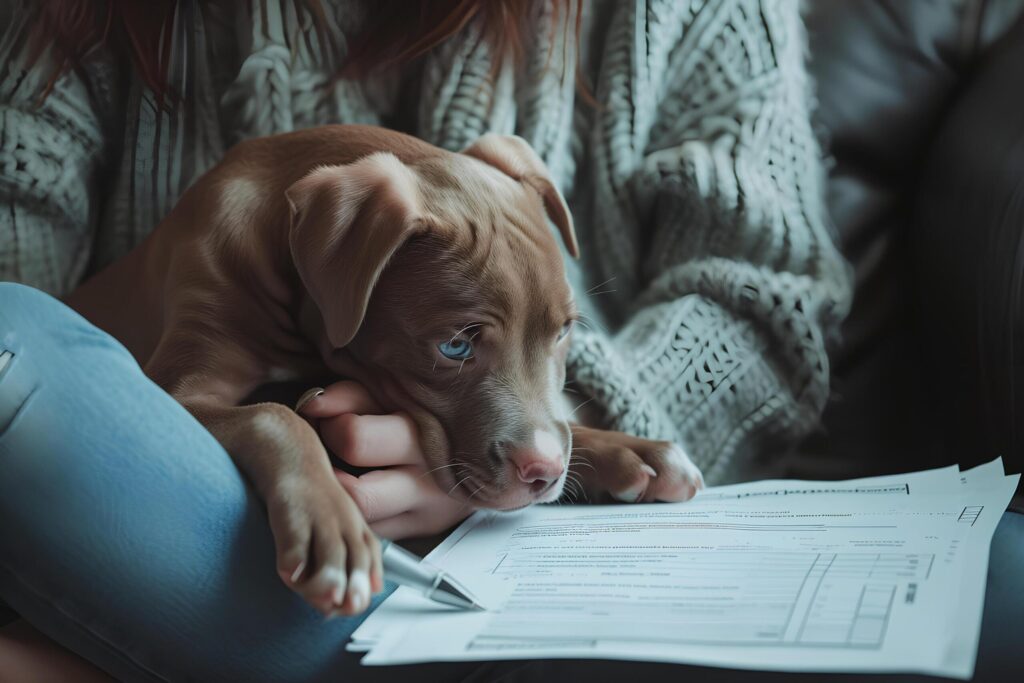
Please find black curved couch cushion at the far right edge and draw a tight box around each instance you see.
[910,13,1024,479]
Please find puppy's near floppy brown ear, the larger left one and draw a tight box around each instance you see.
[285,153,425,348]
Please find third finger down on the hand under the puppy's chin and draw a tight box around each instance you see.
[335,465,425,522]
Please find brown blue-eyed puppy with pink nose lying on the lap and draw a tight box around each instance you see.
[69,126,701,612]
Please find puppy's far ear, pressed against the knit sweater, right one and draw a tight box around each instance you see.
[462,133,580,258]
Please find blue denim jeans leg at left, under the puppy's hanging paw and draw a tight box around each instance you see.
[0,283,509,681]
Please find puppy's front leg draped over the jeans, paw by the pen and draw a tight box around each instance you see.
[146,339,382,614]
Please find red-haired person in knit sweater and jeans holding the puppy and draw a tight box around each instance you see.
[0,0,851,681]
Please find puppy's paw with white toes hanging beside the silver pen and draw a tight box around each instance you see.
[267,477,383,616]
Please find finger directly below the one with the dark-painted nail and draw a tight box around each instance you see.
[317,411,423,467]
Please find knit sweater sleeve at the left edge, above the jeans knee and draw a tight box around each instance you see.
[0,2,114,296]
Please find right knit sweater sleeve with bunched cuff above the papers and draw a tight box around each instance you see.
[569,1,851,482]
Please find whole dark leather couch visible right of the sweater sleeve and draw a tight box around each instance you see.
[784,0,1024,497]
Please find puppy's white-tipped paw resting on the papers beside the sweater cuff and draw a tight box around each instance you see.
[569,426,703,503]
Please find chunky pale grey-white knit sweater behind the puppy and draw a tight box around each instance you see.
[0,0,851,482]
